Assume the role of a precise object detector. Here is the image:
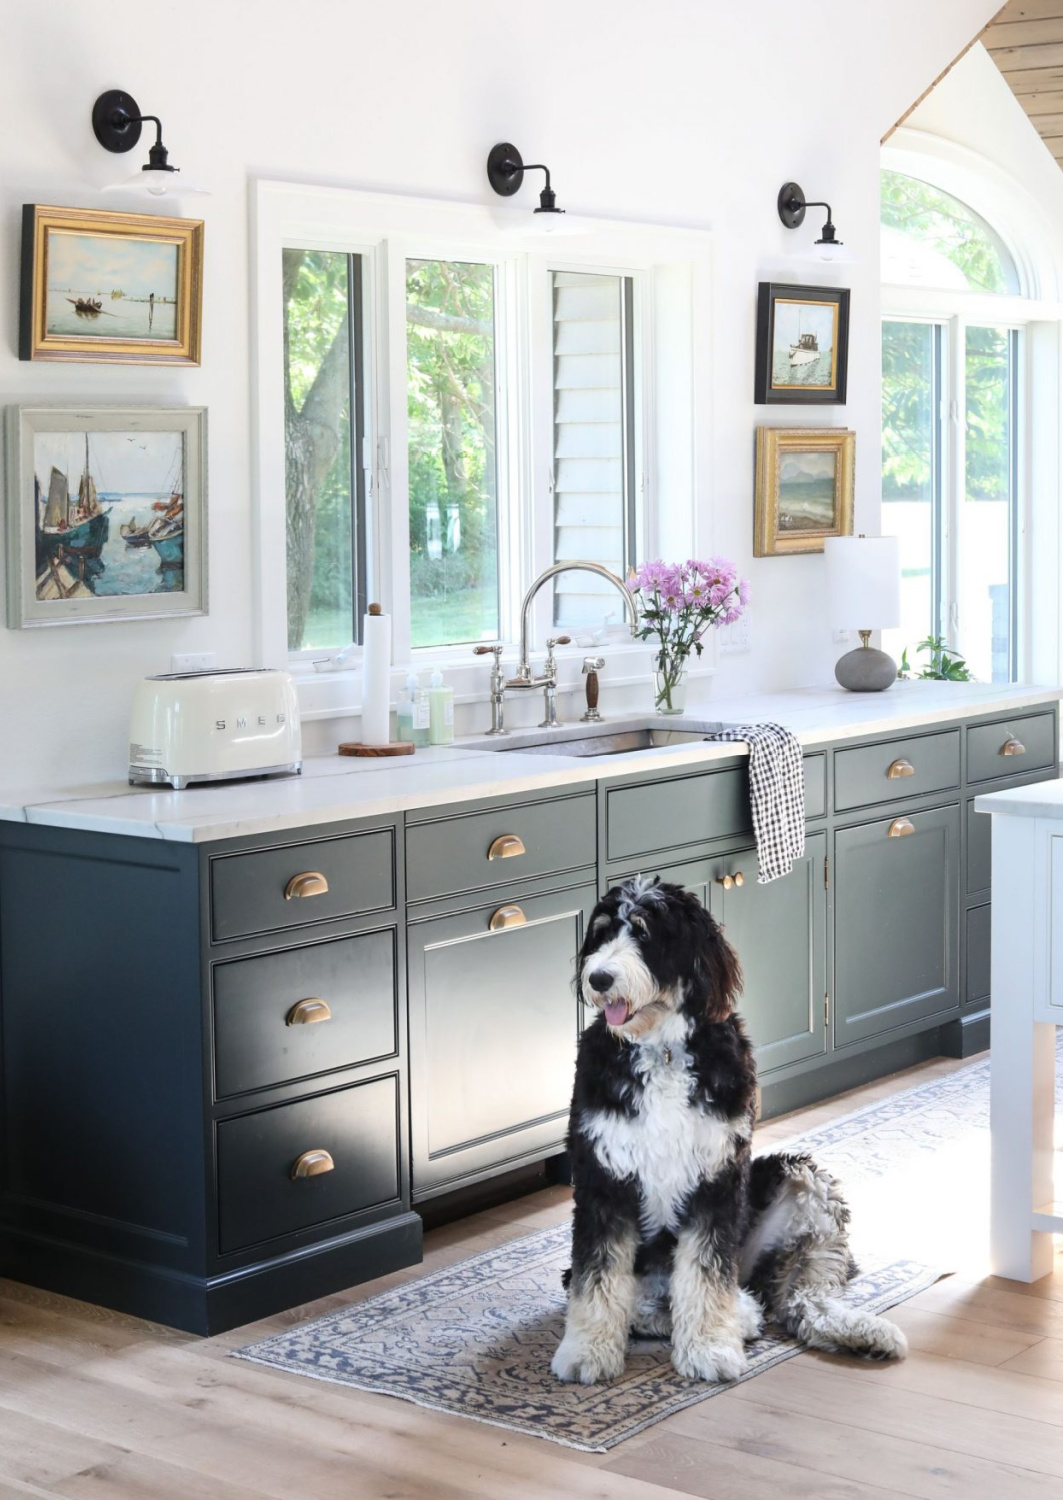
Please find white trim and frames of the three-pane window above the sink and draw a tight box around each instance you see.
[250,180,714,719]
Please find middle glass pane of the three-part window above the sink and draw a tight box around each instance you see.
[406,261,499,648]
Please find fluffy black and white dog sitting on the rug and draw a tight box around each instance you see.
[552,879,907,1385]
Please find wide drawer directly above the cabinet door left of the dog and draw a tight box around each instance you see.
[406,792,597,902]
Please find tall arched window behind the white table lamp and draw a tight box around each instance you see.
[882,171,1024,683]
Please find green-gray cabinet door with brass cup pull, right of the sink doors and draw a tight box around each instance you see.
[832,806,960,1047]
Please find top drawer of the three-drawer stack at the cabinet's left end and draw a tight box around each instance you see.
[210,828,396,942]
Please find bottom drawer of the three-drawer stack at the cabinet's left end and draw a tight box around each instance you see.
[217,1077,399,1254]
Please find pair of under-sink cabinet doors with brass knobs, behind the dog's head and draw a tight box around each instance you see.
[610,834,826,1073]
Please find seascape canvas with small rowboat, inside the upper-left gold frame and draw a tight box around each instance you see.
[45,231,177,339]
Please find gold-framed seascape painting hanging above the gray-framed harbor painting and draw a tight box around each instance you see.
[18,203,202,365]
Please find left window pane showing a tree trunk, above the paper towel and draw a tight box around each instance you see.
[283,249,366,651]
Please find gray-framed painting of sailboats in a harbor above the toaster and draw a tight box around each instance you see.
[6,407,207,630]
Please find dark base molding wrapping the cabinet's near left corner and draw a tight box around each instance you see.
[0,1214,421,1337]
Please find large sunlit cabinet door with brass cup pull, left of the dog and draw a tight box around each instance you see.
[408,885,595,1199]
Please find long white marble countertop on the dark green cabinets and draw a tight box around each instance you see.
[0,681,1063,843]
